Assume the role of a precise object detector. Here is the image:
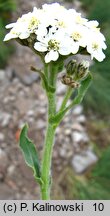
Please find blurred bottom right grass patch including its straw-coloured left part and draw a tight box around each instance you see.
[65,147,110,200]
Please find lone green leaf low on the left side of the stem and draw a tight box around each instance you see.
[20,124,42,183]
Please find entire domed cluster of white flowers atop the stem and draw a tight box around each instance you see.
[4,3,106,63]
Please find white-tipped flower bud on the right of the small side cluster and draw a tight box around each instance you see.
[76,61,89,79]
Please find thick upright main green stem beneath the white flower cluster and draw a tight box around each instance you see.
[41,65,57,200]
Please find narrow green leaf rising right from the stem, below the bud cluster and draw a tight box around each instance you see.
[49,73,92,127]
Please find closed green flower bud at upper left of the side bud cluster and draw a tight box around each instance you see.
[66,60,77,75]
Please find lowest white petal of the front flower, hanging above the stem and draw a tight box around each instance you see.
[45,50,59,63]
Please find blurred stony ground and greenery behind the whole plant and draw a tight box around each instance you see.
[0,0,110,199]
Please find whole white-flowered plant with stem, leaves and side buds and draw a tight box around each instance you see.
[4,3,107,199]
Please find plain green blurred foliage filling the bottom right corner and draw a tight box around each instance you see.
[80,148,110,200]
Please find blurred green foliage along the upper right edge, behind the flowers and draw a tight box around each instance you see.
[80,0,110,114]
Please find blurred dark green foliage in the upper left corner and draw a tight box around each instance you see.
[0,0,16,68]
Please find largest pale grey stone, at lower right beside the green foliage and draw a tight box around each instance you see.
[71,149,98,174]
